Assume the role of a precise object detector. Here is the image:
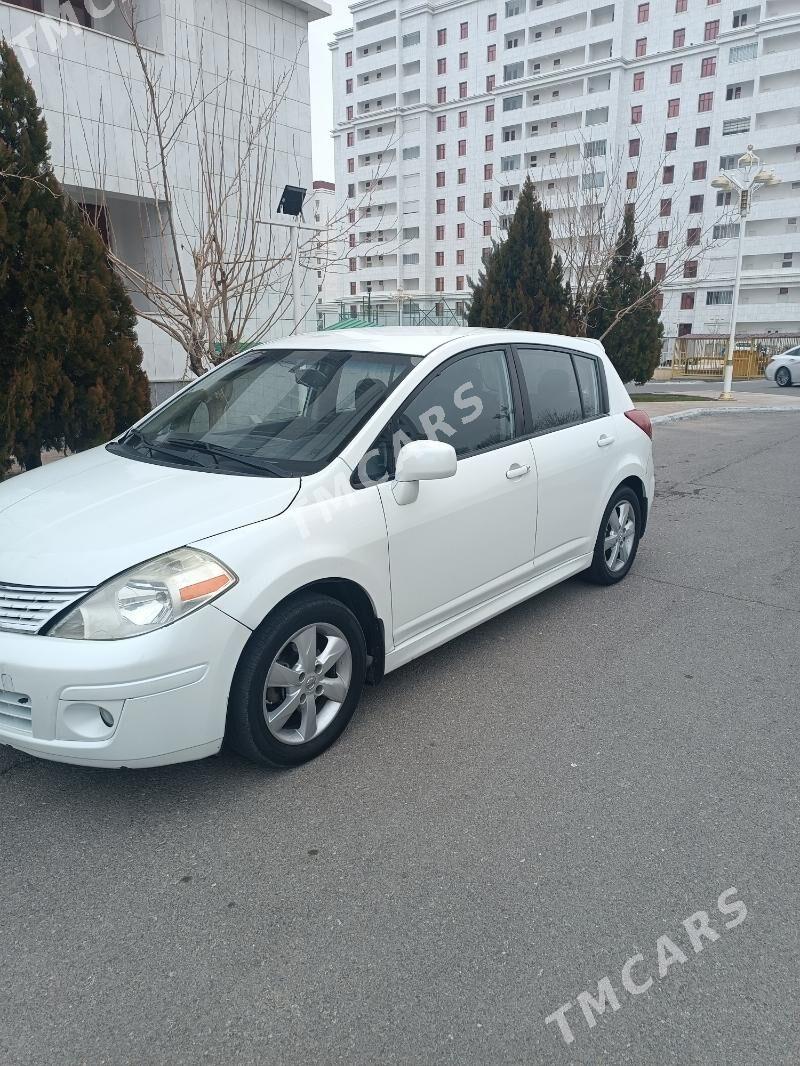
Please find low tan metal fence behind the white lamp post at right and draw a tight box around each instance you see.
[660,333,800,378]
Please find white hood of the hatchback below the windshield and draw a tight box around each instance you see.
[0,448,300,587]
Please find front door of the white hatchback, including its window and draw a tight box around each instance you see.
[380,348,537,645]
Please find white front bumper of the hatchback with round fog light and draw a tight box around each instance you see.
[0,604,251,768]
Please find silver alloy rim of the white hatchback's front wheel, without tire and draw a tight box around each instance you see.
[263,623,353,744]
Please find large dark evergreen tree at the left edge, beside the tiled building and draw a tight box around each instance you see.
[0,41,149,477]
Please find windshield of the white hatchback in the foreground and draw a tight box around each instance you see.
[108,349,419,477]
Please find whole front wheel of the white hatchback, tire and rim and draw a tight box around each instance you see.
[226,596,367,766]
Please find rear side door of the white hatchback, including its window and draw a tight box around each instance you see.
[515,345,618,572]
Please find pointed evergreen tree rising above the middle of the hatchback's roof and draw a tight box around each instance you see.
[468,178,572,334]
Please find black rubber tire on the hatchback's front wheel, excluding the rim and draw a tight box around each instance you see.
[225,595,367,768]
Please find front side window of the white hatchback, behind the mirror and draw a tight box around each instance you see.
[395,350,514,458]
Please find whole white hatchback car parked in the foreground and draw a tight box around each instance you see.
[0,328,654,766]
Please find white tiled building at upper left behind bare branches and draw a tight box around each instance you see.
[0,0,331,399]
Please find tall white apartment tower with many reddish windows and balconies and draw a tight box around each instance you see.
[331,0,800,334]
